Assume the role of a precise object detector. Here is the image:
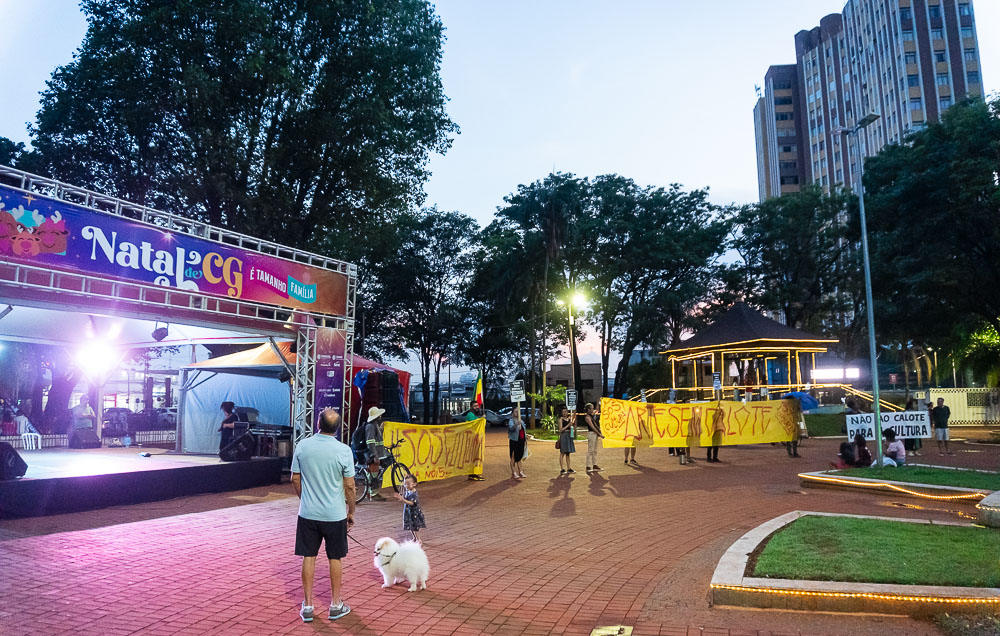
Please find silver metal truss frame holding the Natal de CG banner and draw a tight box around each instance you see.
[0,166,358,444]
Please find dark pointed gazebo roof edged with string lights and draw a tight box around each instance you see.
[661,302,837,356]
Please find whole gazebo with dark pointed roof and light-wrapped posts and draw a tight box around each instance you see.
[660,303,837,400]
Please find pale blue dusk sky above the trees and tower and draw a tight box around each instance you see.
[0,0,1000,376]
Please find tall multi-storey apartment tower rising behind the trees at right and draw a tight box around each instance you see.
[754,0,983,200]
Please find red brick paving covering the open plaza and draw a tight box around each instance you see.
[0,433,1000,636]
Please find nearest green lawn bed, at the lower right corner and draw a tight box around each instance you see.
[753,516,1000,587]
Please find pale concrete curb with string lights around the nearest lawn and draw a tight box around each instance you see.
[710,510,1000,616]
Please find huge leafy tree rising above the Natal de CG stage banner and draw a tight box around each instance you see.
[30,0,455,247]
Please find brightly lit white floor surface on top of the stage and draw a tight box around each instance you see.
[18,447,223,479]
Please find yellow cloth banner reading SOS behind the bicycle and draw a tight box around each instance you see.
[382,418,486,487]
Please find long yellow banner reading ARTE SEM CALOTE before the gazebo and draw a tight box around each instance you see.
[601,398,801,448]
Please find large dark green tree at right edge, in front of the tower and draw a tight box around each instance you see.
[865,99,1000,344]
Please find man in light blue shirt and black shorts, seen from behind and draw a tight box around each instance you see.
[292,409,355,623]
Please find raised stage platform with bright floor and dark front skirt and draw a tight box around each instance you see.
[0,447,282,518]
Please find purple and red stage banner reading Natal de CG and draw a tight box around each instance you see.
[0,185,347,316]
